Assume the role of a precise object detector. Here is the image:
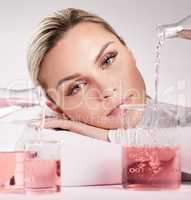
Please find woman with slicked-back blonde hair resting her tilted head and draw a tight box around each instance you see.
[28,8,191,180]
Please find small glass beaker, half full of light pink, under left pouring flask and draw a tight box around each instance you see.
[24,127,62,193]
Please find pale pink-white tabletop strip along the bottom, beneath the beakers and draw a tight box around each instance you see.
[0,184,191,200]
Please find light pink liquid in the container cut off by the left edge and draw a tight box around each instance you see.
[0,151,33,192]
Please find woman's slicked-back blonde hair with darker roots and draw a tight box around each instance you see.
[27,8,125,85]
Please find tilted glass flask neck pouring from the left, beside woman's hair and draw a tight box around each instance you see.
[0,87,47,122]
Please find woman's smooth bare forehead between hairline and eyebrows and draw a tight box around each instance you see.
[41,22,119,86]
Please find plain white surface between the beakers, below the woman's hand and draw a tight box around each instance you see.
[59,131,121,186]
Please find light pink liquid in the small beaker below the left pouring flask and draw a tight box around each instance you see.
[25,158,61,193]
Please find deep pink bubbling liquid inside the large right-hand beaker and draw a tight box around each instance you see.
[122,146,181,188]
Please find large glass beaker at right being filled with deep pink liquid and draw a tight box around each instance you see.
[120,104,181,189]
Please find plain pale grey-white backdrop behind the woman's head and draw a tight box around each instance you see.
[0,0,191,146]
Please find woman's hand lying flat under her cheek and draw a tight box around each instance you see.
[45,117,108,141]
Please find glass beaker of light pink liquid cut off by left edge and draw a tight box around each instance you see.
[0,123,36,193]
